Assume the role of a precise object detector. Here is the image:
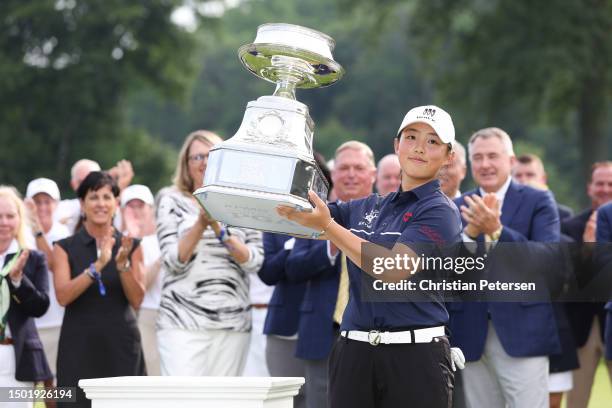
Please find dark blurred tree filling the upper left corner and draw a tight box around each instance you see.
[0,0,206,196]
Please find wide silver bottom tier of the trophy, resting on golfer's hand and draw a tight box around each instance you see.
[193,186,318,238]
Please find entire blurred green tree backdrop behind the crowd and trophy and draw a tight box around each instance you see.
[0,0,612,209]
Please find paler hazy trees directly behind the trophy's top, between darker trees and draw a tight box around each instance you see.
[129,0,430,163]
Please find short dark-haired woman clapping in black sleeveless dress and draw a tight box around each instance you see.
[53,172,145,408]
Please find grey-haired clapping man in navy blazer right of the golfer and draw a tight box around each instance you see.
[449,128,560,408]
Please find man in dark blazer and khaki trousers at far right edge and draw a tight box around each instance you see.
[561,161,612,408]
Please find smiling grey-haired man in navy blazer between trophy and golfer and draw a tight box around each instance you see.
[286,141,376,408]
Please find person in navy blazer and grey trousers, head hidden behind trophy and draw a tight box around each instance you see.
[258,232,306,408]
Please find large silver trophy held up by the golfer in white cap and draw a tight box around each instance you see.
[194,24,344,237]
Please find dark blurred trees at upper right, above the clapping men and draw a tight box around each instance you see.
[339,0,612,205]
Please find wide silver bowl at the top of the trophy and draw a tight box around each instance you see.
[238,23,344,88]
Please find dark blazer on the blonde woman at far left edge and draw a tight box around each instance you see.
[5,251,53,382]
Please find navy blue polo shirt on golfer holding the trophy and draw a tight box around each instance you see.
[329,180,461,331]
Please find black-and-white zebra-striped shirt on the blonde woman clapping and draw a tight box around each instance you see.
[156,187,263,332]
